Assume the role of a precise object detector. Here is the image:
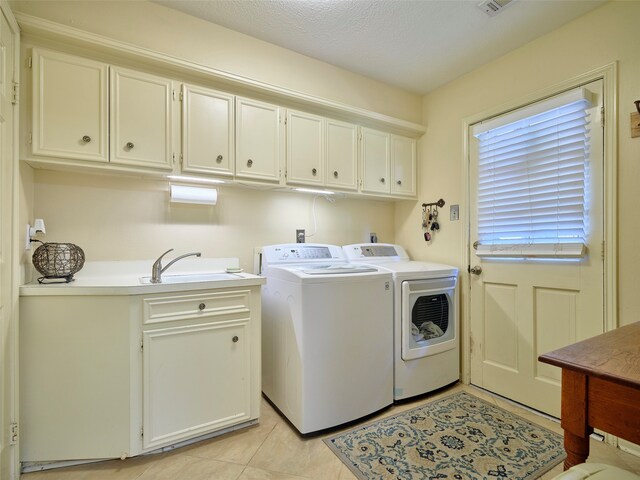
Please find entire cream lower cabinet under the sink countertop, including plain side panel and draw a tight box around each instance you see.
[20,286,260,467]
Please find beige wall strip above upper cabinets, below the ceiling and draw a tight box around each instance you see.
[11,0,422,123]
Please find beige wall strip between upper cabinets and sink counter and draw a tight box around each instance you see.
[33,170,394,271]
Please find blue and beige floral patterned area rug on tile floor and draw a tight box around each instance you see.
[324,392,565,480]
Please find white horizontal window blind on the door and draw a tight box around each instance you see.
[473,89,591,257]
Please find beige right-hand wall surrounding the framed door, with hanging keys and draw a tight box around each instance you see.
[395,1,640,324]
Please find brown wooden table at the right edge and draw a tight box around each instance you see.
[538,322,640,470]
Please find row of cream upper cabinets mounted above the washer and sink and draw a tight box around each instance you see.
[25,48,417,198]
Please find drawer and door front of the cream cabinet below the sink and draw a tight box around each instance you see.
[142,290,252,450]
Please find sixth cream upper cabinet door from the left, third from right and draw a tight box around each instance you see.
[326,120,358,190]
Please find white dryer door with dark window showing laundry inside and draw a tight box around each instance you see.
[401,277,458,360]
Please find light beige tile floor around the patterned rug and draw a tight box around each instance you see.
[22,384,640,480]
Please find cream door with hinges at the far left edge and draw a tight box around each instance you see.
[0,1,20,479]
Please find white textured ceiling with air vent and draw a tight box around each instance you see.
[155,0,605,94]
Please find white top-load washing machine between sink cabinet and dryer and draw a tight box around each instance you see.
[261,243,393,434]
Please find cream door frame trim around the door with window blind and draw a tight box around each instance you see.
[460,62,618,384]
